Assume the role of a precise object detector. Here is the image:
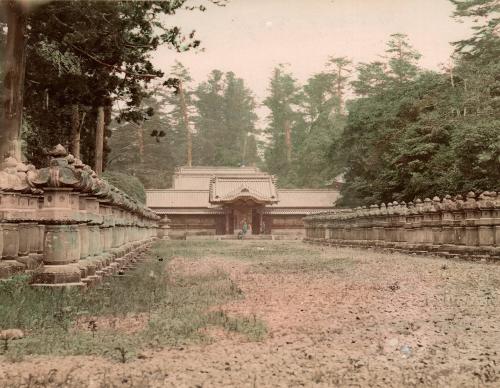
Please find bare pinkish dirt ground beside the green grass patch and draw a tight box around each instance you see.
[0,241,500,387]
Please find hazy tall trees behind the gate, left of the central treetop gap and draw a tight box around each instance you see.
[108,63,260,188]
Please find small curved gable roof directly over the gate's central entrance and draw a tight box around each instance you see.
[209,173,278,204]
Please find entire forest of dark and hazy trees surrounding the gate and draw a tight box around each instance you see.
[0,0,500,206]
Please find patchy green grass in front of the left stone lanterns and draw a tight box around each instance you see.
[0,242,266,362]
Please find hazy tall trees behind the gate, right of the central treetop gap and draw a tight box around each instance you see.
[264,57,350,187]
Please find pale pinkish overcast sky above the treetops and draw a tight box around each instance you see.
[154,0,470,101]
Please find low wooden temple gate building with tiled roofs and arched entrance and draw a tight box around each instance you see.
[146,167,339,238]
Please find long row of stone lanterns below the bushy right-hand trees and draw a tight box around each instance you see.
[304,191,500,259]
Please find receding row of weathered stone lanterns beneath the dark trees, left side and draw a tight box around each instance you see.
[0,145,165,286]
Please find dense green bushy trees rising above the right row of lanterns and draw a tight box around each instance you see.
[332,21,500,206]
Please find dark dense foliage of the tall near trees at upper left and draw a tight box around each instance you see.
[20,0,207,165]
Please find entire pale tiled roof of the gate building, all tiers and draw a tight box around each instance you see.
[146,167,339,214]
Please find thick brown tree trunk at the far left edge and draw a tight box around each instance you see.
[0,0,26,159]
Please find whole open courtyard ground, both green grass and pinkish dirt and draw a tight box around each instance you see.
[0,240,500,388]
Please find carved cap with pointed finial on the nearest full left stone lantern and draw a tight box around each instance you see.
[30,144,80,189]
